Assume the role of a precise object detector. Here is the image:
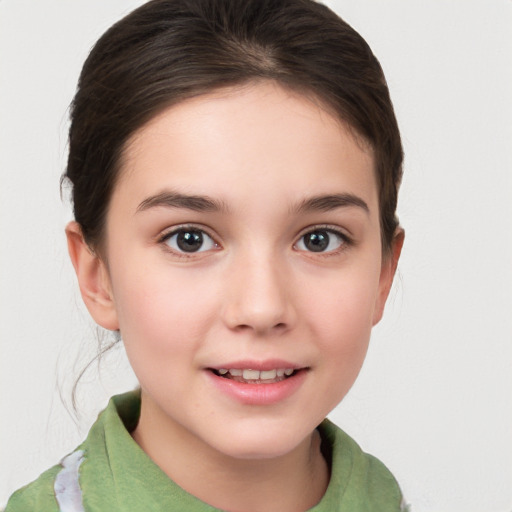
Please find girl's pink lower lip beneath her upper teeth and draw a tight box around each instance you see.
[207,369,307,405]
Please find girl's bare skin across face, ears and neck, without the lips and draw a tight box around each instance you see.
[67,82,403,512]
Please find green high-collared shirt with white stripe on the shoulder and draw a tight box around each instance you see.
[5,392,405,512]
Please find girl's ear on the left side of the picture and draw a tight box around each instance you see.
[66,221,119,331]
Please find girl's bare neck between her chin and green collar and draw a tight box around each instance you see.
[132,392,329,512]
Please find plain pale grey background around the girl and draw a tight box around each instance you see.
[0,0,512,512]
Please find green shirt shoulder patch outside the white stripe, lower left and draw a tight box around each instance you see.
[5,465,62,512]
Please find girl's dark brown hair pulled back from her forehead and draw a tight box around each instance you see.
[63,0,403,251]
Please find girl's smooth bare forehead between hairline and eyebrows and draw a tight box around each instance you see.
[114,82,376,212]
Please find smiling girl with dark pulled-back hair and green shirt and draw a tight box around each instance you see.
[7,0,404,512]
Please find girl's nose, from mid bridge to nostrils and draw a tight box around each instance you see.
[223,251,297,335]
